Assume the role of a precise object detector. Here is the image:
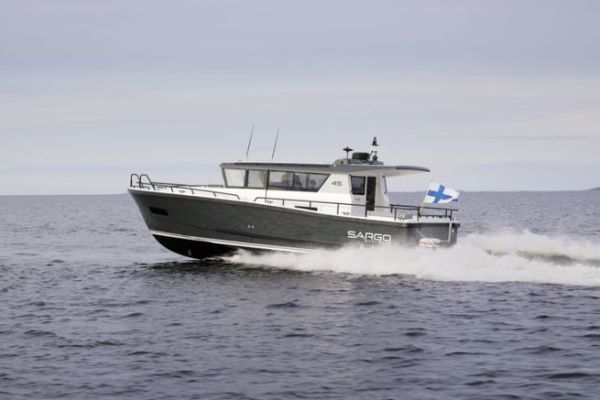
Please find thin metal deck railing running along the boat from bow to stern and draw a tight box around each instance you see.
[129,174,458,221]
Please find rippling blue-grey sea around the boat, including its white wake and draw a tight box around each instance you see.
[0,191,600,399]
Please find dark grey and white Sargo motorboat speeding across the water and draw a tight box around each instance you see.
[128,139,460,259]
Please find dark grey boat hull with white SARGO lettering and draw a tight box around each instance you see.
[129,189,459,259]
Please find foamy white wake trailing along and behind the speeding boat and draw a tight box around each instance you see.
[226,231,600,286]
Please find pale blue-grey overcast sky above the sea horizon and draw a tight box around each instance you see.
[0,0,600,195]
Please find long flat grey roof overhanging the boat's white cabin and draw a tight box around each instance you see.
[221,162,429,176]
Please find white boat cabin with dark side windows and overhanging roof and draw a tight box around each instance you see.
[221,149,429,217]
